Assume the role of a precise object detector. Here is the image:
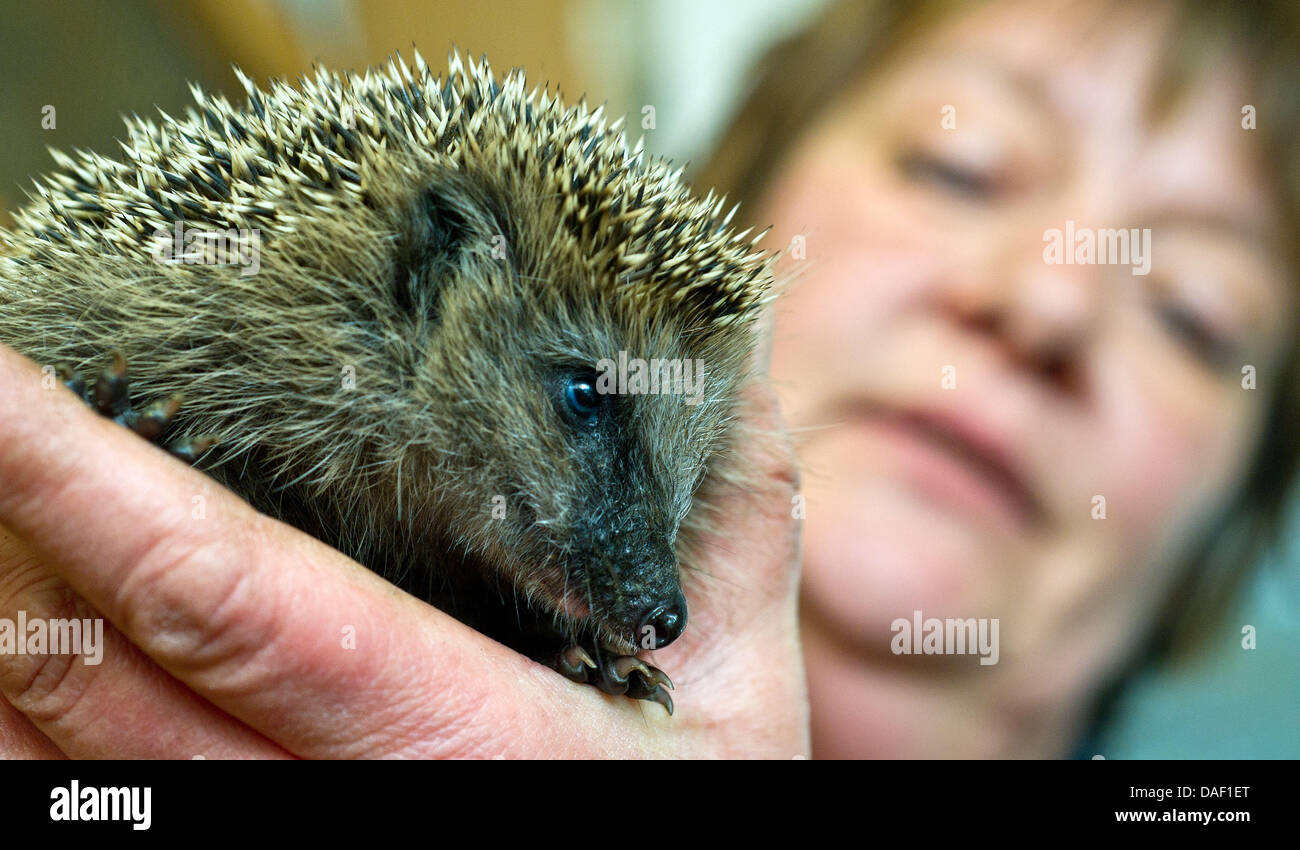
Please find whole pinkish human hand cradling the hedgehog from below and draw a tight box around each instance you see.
[0,346,809,758]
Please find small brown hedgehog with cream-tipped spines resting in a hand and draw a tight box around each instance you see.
[0,52,774,715]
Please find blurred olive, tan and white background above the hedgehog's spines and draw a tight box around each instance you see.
[0,0,823,226]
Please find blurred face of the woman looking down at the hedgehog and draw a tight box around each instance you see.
[761,1,1291,751]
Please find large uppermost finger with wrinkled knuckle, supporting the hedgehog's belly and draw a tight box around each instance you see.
[0,346,595,756]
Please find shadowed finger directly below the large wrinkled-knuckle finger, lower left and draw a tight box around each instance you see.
[0,528,289,759]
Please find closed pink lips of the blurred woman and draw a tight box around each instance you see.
[852,406,1044,530]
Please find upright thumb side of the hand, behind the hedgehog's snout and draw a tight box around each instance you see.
[654,378,810,758]
